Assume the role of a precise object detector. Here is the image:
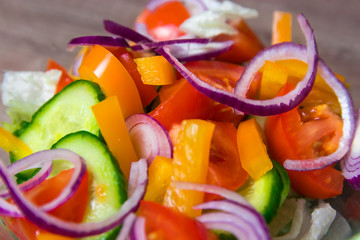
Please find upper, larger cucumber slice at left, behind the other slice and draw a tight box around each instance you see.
[11,80,105,181]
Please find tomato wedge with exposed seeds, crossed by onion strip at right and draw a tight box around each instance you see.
[265,83,344,199]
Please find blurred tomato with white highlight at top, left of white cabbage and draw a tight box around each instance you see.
[135,1,190,41]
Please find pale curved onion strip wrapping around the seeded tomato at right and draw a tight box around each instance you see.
[284,59,355,171]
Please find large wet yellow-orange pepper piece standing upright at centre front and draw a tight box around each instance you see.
[163,119,215,217]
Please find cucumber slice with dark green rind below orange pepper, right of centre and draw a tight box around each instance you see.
[237,163,287,223]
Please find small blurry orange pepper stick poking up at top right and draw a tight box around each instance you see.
[271,11,292,44]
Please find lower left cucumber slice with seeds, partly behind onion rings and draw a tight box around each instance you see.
[52,131,127,240]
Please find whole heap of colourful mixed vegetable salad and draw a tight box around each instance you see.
[0,0,360,240]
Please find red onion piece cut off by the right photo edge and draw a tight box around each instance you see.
[341,109,360,190]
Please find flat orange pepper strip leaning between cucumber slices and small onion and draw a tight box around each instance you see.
[92,96,138,179]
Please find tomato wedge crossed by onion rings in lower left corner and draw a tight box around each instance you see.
[2,169,89,240]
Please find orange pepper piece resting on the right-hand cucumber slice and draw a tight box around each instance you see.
[237,118,273,180]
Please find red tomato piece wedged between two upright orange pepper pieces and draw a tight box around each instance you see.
[205,122,248,201]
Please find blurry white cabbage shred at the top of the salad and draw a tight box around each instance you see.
[180,0,258,38]
